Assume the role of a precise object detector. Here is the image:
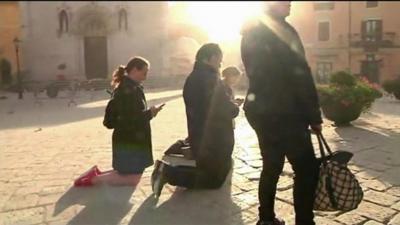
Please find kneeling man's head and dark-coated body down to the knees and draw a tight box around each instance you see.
[183,43,239,188]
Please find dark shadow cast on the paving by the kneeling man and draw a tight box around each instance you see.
[129,171,243,225]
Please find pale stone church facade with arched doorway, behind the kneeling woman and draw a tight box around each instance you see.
[19,1,168,80]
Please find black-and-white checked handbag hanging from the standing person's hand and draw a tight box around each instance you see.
[314,134,364,211]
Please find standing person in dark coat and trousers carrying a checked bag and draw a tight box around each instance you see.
[241,2,322,225]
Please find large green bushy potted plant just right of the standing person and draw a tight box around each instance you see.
[317,71,382,126]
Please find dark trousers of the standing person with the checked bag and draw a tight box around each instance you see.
[246,113,319,225]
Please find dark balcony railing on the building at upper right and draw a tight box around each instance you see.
[350,32,398,50]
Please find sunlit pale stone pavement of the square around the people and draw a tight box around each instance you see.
[0,90,400,225]
